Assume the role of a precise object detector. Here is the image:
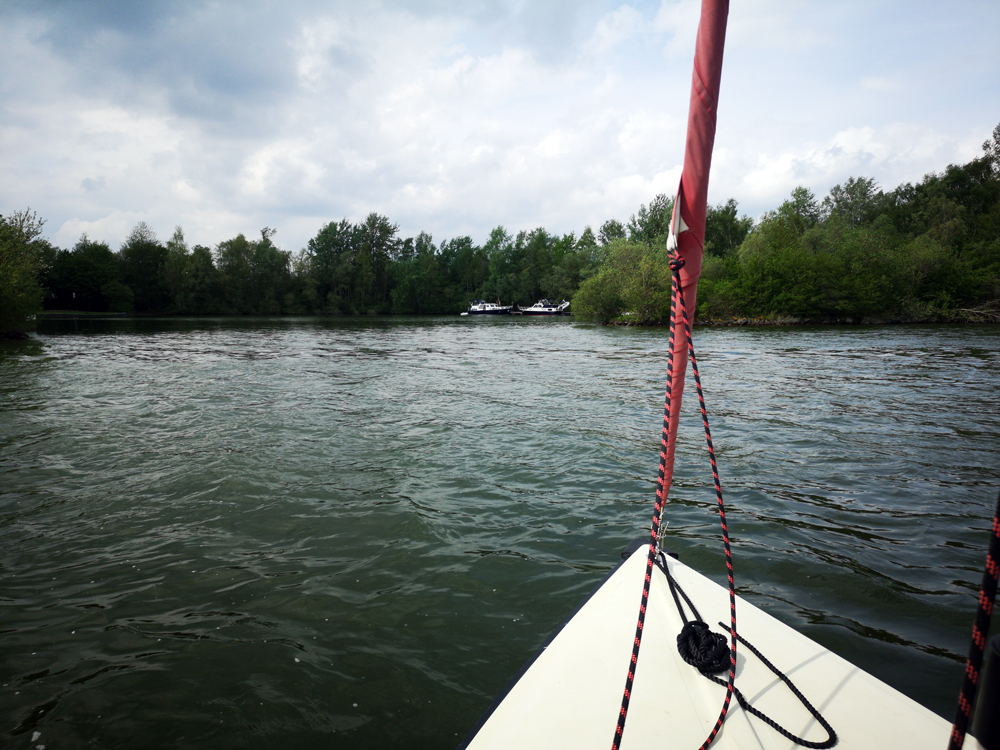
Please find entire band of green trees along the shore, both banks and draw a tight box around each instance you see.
[0,125,1000,333]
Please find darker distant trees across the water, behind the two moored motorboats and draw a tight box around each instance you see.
[0,189,738,330]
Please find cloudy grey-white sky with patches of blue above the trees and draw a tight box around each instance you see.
[0,0,1000,251]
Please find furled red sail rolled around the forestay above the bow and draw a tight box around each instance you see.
[663,0,729,498]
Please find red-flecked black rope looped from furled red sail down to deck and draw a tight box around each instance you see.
[611,258,737,750]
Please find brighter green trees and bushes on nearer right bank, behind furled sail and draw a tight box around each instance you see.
[573,125,1000,324]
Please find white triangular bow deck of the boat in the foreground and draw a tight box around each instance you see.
[461,545,981,750]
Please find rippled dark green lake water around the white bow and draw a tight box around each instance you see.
[0,317,1000,750]
